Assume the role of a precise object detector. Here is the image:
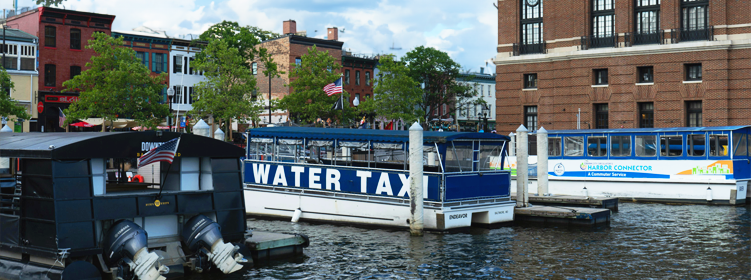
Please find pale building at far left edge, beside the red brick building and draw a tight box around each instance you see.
[0,28,39,132]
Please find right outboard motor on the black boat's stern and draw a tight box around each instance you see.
[181,215,245,274]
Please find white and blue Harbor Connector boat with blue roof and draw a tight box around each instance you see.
[506,126,751,204]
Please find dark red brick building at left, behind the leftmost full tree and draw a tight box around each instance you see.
[6,7,115,131]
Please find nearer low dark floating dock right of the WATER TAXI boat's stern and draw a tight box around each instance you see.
[514,205,610,226]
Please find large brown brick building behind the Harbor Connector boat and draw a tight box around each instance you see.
[495,0,751,134]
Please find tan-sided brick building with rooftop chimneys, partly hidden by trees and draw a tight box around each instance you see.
[251,20,346,124]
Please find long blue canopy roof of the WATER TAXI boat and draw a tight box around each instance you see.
[247,127,509,143]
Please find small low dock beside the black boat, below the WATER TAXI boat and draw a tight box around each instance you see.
[245,231,310,264]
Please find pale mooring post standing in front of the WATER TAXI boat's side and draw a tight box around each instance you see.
[409,122,425,236]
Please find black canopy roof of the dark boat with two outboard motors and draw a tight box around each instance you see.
[0,131,245,160]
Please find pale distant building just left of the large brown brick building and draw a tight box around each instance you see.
[454,68,496,132]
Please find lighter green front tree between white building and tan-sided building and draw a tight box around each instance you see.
[189,39,263,140]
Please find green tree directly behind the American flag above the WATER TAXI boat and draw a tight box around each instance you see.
[279,46,357,124]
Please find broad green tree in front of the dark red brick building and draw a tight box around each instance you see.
[63,32,169,129]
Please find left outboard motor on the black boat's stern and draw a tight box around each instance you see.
[104,220,169,280]
